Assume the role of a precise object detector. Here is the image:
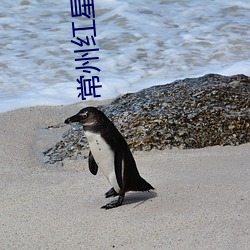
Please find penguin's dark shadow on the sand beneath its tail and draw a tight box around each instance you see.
[123,191,157,208]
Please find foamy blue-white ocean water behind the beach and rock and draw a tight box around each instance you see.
[0,0,250,112]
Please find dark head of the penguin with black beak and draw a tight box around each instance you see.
[64,107,108,128]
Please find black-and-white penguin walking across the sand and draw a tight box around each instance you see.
[65,107,154,209]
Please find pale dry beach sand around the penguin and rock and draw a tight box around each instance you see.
[0,100,250,250]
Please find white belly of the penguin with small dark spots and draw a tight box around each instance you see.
[85,131,120,193]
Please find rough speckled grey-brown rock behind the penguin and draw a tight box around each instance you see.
[44,74,250,163]
